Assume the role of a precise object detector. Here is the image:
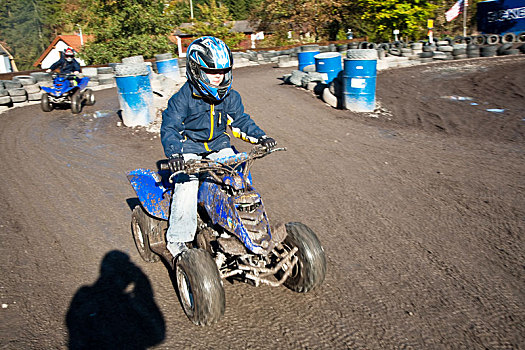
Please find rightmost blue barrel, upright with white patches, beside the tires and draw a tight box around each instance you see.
[343,58,377,112]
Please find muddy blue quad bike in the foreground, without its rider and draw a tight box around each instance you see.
[128,146,326,325]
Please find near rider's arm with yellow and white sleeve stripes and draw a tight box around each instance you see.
[227,90,265,143]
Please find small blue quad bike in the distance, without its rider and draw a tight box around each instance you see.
[40,74,95,114]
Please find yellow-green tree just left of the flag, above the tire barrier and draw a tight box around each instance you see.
[359,0,438,41]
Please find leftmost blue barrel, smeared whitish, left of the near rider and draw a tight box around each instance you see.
[115,74,155,126]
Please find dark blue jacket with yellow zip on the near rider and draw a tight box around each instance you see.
[160,82,265,157]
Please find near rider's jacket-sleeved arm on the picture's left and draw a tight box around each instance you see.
[160,89,188,158]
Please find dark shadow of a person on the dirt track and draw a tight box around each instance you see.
[66,250,166,350]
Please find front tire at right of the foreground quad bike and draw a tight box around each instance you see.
[277,222,326,293]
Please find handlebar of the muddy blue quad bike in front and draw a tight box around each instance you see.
[160,145,286,183]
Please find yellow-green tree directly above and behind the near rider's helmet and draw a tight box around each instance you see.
[181,0,244,48]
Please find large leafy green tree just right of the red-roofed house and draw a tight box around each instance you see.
[77,0,175,64]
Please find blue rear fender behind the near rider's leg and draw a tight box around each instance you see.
[127,169,171,220]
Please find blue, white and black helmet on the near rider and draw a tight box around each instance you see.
[186,36,233,102]
